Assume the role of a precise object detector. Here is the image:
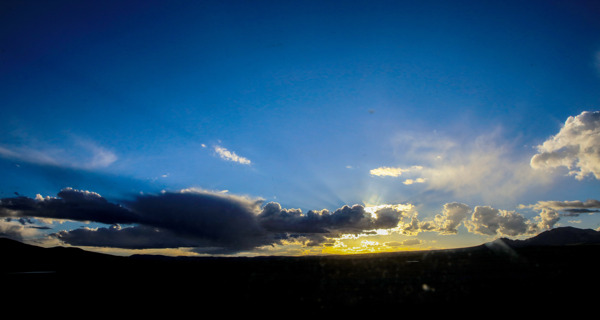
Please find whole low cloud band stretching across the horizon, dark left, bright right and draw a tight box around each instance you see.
[0,188,600,254]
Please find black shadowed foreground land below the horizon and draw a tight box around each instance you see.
[0,230,600,315]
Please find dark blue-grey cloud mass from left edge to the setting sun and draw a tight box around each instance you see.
[0,188,412,253]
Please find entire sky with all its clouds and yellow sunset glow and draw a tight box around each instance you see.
[0,0,600,256]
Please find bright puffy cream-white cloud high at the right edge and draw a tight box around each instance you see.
[530,111,600,180]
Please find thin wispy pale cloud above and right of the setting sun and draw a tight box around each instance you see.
[371,131,551,203]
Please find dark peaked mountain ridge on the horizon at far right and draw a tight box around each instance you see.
[494,227,600,248]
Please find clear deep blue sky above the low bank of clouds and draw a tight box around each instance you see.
[0,1,600,255]
